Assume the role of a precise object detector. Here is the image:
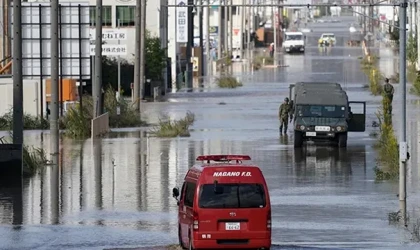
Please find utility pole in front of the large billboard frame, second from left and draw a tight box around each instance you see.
[50,0,59,164]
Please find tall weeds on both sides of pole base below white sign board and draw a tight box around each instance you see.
[60,86,146,139]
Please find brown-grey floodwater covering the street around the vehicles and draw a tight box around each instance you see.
[0,16,420,249]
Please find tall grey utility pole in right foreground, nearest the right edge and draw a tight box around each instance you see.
[398,0,408,225]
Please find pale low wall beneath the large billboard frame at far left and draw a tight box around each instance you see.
[0,78,45,116]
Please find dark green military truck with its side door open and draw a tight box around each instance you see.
[289,82,366,148]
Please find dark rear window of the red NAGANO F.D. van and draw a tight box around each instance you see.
[199,183,266,208]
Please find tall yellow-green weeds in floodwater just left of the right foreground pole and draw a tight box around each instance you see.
[375,92,399,180]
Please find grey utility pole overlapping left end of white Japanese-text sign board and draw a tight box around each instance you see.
[93,0,103,117]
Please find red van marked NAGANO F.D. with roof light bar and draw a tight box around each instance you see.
[173,155,271,250]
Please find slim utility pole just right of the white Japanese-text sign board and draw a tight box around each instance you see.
[139,0,146,99]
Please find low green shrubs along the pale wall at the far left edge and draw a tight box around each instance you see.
[0,109,50,130]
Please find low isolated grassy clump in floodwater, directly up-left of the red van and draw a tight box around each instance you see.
[151,111,195,138]
